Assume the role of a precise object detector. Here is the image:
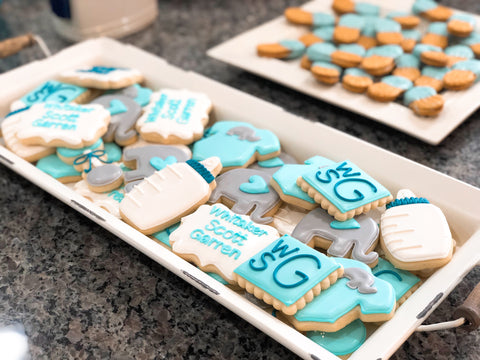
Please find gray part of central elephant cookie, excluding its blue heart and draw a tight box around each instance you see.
[209,169,281,224]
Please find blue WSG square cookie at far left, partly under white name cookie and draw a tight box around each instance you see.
[10,80,92,111]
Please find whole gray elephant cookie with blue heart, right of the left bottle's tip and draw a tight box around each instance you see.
[209,169,281,224]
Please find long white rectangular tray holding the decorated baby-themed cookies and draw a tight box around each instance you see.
[0,39,480,360]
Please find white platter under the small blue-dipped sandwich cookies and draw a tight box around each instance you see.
[207,0,480,145]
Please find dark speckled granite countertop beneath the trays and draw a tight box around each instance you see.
[0,0,480,360]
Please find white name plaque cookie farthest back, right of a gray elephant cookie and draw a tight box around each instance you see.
[137,89,212,144]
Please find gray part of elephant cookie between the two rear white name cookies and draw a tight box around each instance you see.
[91,94,142,145]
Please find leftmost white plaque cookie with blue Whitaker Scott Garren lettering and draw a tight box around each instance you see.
[16,102,110,149]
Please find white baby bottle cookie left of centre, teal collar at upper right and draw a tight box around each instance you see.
[120,157,222,235]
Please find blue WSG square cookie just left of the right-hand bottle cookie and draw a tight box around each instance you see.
[297,160,392,221]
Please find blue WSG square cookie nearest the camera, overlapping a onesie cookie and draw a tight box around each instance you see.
[234,235,343,315]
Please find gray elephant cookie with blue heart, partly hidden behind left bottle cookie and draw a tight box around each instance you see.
[123,145,190,192]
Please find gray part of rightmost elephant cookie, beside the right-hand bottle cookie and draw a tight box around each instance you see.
[292,208,379,264]
